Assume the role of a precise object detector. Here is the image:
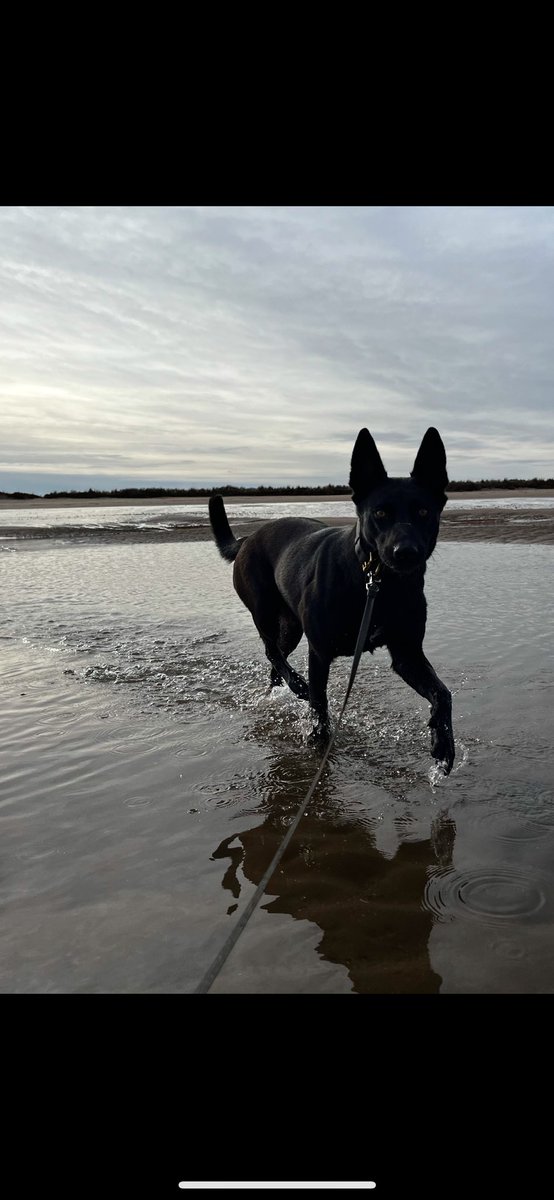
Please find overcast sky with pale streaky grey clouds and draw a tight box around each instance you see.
[0,205,554,492]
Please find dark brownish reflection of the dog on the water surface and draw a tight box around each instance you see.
[212,748,456,994]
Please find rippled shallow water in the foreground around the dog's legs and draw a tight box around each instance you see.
[0,520,554,992]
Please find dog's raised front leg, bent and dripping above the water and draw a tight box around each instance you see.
[389,646,456,775]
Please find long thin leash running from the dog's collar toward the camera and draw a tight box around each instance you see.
[194,557,380,995]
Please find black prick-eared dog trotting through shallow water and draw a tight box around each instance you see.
[210,428,454,774]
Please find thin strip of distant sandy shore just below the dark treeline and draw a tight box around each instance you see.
[0,487,554,511]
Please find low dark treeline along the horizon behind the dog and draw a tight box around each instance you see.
[0,479,554,500]
